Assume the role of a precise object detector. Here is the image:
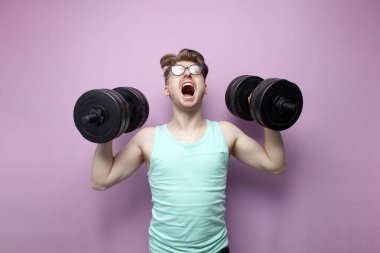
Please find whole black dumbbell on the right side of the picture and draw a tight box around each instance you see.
[225,75,303,131]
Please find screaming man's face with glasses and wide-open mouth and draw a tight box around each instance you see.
[165,61,207,107]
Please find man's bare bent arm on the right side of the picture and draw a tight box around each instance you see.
[221,122,286,174]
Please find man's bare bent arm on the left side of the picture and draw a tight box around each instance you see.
[91,129,151,190]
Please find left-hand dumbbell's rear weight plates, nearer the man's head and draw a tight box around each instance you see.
[113,87,149,133]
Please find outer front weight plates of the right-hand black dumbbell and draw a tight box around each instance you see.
[250,78,303,131]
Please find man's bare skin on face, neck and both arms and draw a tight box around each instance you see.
[92,61,286,190]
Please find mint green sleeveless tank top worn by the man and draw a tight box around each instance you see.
[148,120,229,253]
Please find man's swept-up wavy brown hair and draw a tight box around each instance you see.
[160,48,208,83]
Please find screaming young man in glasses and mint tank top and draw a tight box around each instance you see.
[92,49,285,253]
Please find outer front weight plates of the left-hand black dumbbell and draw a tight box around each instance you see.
[74,89,125,143]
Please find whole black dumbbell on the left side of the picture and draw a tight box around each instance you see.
[74,87,149,143]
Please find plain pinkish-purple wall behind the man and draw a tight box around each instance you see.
[0,0,380,253]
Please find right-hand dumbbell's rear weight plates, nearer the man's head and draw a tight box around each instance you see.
[225,75,263,121]
